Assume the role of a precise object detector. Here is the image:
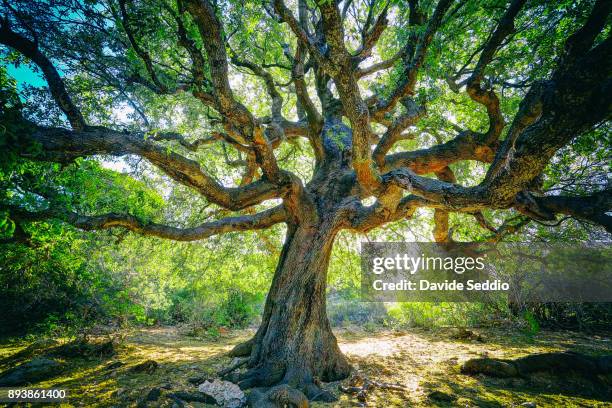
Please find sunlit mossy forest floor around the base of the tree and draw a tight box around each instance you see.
[0,327,612,408]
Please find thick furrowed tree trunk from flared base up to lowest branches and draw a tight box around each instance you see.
[232,218,350,400]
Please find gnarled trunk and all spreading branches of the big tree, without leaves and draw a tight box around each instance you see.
[0,0,612,406]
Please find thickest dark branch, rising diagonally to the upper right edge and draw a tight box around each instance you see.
[483,33,612,202]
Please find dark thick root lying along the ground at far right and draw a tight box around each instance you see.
[461,352,612,377]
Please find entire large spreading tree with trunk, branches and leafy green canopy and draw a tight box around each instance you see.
[0,0,612,400]
